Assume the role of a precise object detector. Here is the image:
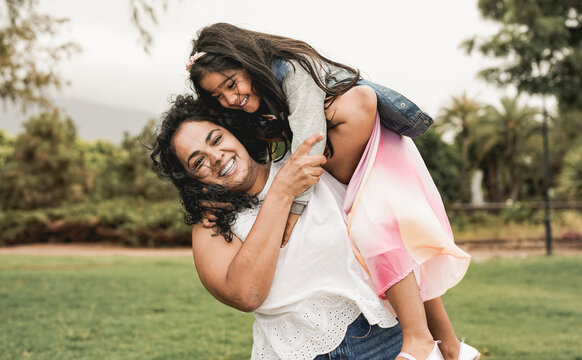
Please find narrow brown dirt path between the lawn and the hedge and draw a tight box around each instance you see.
[0,240,582,261]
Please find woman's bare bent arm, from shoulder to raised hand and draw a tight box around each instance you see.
[192,134,325,312]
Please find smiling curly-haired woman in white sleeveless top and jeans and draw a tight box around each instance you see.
[152,96,402,359]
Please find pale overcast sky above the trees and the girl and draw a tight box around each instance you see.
[40,0,500,115]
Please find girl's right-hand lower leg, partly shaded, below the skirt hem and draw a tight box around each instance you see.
[424,297,461,360]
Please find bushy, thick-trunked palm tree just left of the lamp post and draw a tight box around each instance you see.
[471,97,540,201]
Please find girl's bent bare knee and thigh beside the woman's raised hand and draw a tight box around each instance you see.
[323,86,377,184]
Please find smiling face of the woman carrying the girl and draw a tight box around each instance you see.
[172,121,261,194]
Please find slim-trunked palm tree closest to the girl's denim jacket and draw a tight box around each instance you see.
[437,93,482,201]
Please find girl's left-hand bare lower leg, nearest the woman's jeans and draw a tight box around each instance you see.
[386,273,434,360]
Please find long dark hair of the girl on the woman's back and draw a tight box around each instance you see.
[189,23,360,143]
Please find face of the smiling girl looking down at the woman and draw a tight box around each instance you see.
[199,69,261,113]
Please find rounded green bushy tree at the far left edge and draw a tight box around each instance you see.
[0,112,88,209]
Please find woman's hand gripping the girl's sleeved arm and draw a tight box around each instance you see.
[271,133,326,199]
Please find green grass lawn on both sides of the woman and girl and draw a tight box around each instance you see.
[0,255,582,360]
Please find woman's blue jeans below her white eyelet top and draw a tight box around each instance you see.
[315,314,402,360]
